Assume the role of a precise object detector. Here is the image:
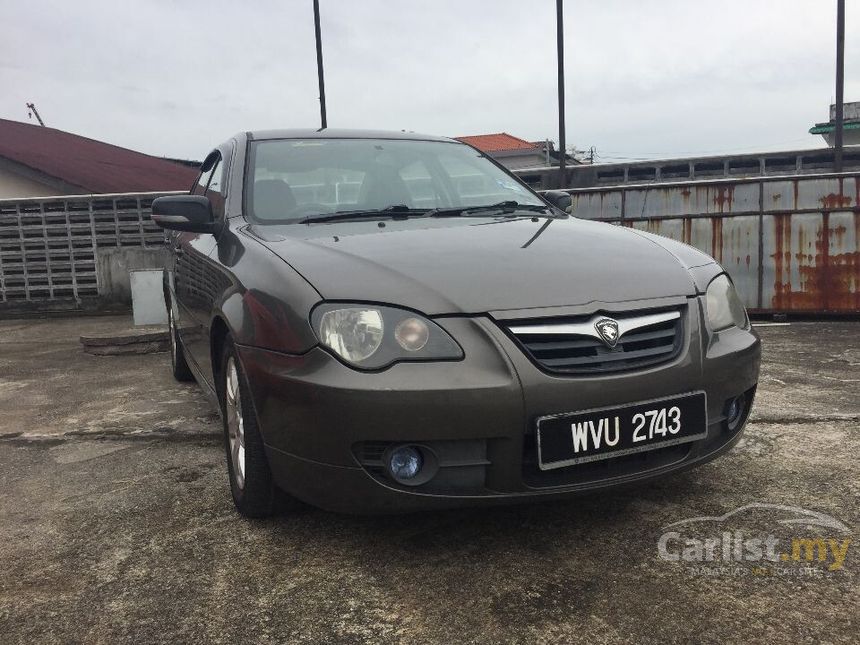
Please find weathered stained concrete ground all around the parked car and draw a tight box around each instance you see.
[0,318,860,643]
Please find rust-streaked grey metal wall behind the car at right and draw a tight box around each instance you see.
[570,173,860,314]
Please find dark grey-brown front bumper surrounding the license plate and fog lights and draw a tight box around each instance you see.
[239,298,760,513]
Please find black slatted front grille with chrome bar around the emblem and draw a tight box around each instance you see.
[504,308,685,374]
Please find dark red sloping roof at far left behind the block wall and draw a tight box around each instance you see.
[0,119,197,193]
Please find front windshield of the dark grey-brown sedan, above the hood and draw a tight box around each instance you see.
[248,139,543,224]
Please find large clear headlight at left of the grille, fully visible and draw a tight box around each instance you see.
[311,303,463,370]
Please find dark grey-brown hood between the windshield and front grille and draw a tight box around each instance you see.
[247,217,713,315]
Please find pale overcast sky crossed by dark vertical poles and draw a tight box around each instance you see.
[0,0,860,161]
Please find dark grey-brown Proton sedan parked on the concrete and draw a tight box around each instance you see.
[152,130,760,516]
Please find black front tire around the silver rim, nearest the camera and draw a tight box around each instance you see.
[218,336,296,518]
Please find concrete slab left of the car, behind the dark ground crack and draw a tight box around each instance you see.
[0,316,218,438]
